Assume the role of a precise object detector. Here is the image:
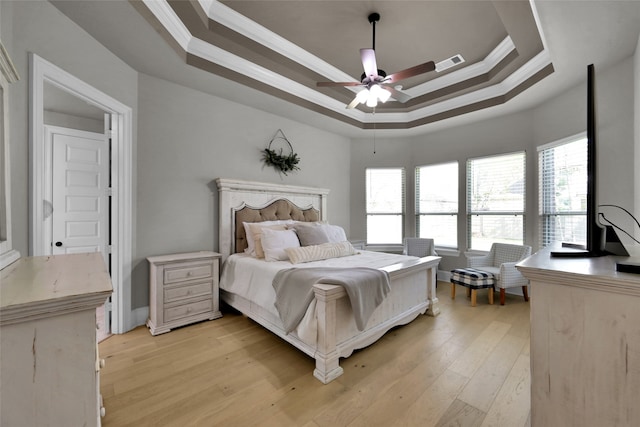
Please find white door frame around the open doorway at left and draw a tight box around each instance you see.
[29,53,136,334]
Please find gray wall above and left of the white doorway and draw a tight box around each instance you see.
[0,1,138,256]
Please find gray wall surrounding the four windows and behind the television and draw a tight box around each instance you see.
[351,58,640,270]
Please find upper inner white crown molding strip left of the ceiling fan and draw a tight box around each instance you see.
[198,0,359,83]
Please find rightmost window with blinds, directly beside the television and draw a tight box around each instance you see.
[538,136,587,247]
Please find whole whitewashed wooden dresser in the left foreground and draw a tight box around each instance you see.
[0,253,112,426]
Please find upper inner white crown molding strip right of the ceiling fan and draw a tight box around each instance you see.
[405,36,516,97]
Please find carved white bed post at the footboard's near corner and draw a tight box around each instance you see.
[313,284,345,384]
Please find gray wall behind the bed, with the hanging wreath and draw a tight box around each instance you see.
[133,74,350,306]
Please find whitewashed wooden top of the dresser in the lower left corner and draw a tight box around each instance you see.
[0,252,113,323]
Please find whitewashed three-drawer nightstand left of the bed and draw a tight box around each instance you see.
[147,251,222,335]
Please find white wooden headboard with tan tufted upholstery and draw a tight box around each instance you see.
[216,178,329,262]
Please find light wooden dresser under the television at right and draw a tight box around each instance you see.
[518,247,640,427]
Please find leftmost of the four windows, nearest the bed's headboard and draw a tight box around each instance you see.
[366,168,405,245]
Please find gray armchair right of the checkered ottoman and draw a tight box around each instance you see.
[467,243,531,305]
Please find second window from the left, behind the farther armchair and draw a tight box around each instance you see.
[416,162,458,248]
